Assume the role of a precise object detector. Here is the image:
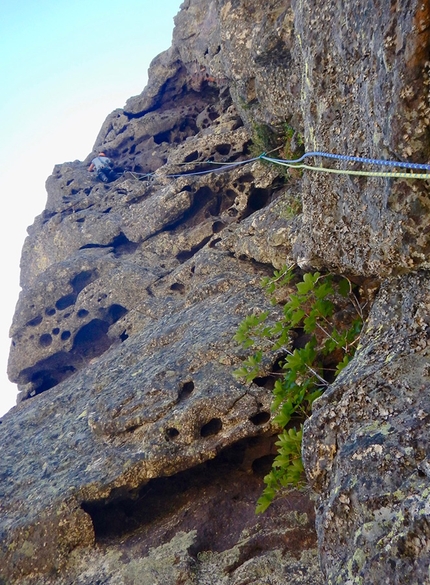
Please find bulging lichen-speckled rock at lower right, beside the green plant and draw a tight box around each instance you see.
[304,271,430,585]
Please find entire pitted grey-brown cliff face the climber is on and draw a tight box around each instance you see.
[0,0,430,585]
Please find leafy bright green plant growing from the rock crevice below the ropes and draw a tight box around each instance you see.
[235,267,363,512]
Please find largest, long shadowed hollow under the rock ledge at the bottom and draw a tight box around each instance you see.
[81,433,288,544]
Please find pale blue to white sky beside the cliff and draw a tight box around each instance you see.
[0,0,181,416]
